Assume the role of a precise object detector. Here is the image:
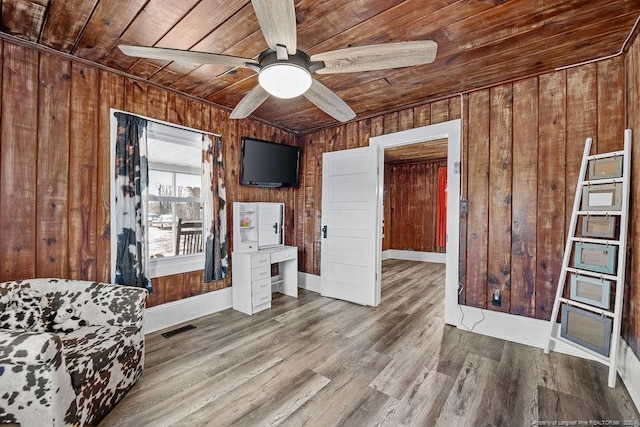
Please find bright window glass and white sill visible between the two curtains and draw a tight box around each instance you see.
[146,121,204,277]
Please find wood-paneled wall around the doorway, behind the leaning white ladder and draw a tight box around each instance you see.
[298,56,640,348]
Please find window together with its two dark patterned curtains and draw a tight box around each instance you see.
[110,109,229,289]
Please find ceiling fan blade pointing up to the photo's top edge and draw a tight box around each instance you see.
[251,0,298,55]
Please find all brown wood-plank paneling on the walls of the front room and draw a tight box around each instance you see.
[0,34,640,362]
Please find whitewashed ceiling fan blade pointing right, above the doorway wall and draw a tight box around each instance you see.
[311,40,438,74]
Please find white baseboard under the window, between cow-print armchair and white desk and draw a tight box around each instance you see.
[144,287,233,334]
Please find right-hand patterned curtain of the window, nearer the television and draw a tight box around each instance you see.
[202,135,229,283]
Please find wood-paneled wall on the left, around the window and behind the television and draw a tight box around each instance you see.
[0,39,297,306]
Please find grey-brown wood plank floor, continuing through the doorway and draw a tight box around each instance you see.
[101,260,639,427]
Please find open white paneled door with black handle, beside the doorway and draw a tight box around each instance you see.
[320,147,380,306]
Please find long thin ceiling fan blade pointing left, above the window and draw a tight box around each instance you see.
[118,45,258,67]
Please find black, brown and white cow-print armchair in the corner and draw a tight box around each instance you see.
[0,279,147,426]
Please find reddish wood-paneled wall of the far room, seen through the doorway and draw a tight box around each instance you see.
[382,160,447,252]
